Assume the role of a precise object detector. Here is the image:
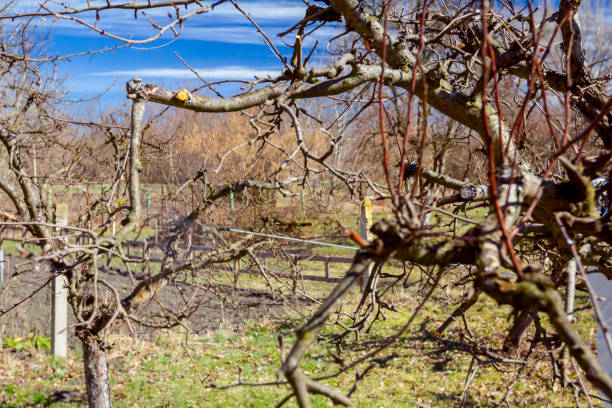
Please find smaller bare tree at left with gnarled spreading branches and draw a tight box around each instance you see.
[0,6,296,407]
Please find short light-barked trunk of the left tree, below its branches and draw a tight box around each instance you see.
[78,332,112,408]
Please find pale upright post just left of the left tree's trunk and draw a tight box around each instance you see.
[51,204,68,358]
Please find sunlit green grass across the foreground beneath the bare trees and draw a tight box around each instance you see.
[0,277,597,408]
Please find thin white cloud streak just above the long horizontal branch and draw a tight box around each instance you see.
[89,66,280,80]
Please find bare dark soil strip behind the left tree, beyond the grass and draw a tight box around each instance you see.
[0,257,312,347]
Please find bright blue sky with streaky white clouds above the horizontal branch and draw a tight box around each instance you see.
[18,0,342,107]
